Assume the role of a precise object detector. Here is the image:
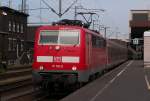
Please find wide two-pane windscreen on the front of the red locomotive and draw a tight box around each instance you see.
[39,30,80,45]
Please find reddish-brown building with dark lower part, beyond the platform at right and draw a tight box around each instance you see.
[129,10,150,59]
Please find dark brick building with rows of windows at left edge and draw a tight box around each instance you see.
[0,7,28,65]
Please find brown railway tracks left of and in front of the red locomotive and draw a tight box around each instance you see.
[0,62,125,101]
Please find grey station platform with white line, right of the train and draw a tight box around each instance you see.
[61,60,150,101]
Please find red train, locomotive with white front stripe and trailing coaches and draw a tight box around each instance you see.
[33,19,127,87]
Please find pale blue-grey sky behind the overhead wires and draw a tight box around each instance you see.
[0,0,150,37]
